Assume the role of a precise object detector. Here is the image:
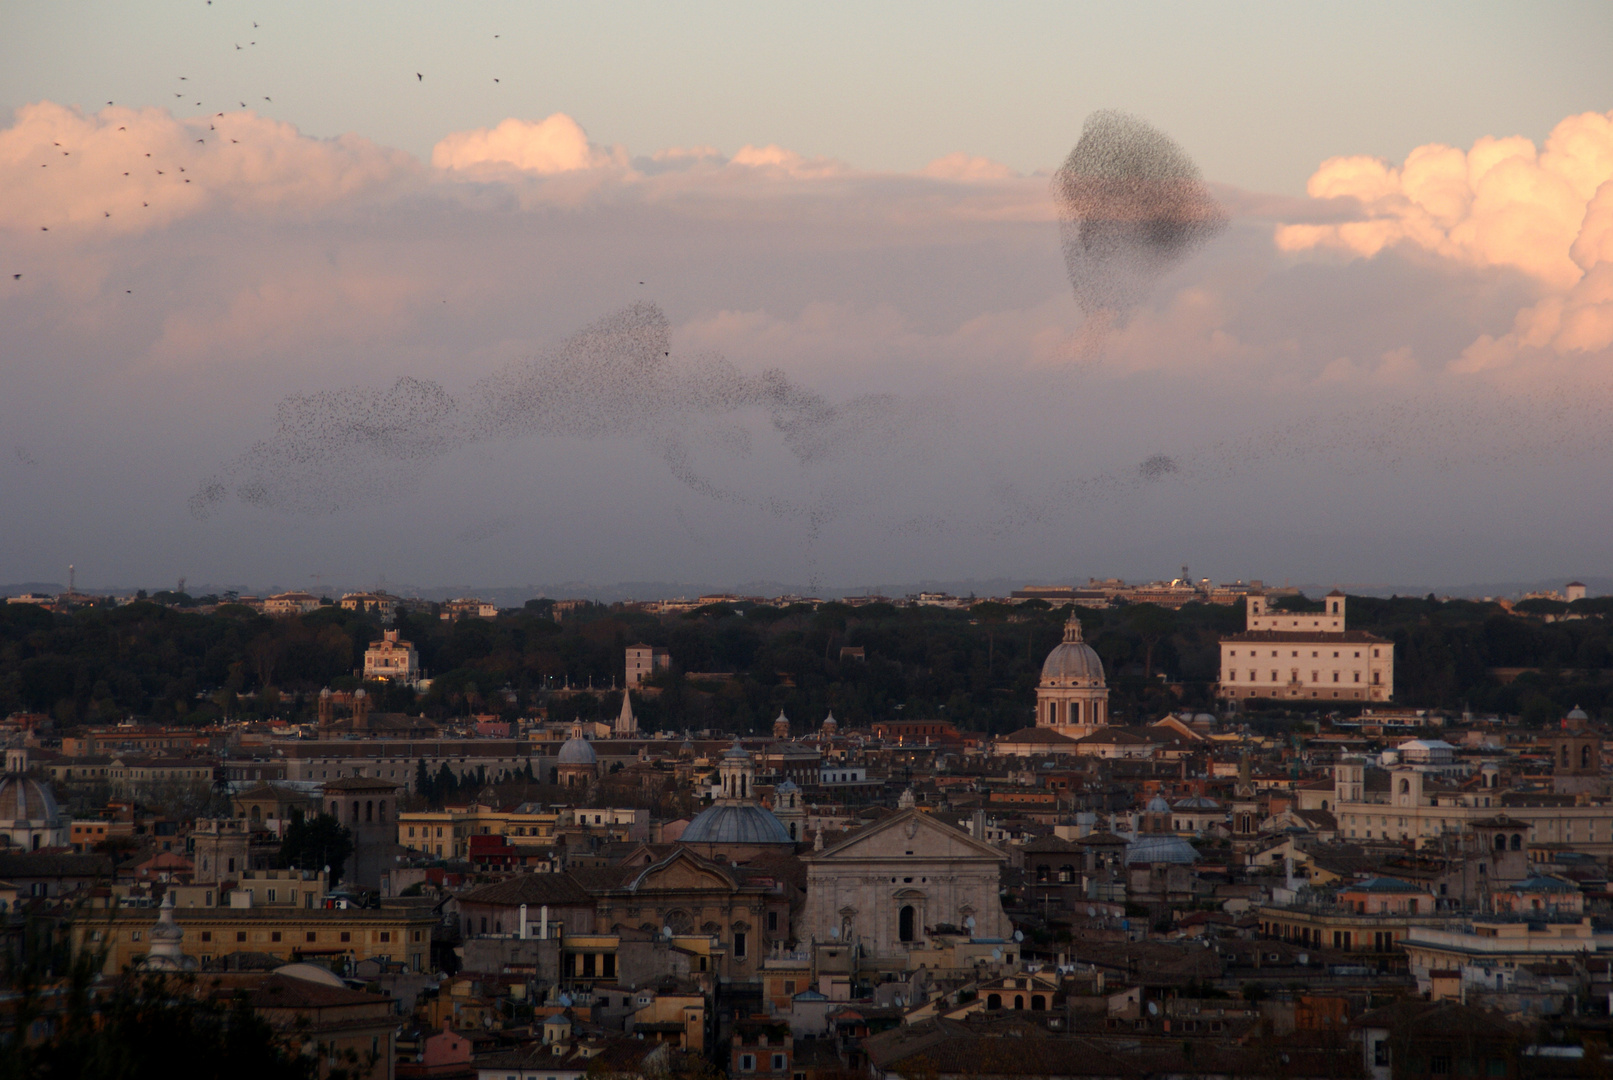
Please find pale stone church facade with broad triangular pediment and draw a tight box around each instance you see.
[797,806,1013,956]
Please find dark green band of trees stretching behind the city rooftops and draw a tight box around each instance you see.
[0,596,1613,732]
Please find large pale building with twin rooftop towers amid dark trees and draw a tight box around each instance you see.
[1218,592,1395,701]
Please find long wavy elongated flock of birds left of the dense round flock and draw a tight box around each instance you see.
[190,301,922,527]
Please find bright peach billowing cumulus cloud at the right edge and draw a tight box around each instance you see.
[1276,113,1613,372]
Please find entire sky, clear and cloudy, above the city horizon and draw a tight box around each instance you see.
[0,0,1613,588]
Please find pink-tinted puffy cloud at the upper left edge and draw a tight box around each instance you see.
[0,102,419,235]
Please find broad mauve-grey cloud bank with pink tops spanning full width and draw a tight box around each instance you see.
[0,103,1613,593]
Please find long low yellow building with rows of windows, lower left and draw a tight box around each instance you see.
[69,906,436,974]
